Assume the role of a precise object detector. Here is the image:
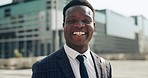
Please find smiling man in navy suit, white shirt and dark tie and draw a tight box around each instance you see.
[32,0,111,78]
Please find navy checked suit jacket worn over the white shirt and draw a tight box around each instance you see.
[32,47,111,78]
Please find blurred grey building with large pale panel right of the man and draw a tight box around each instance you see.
[93,10,148,53]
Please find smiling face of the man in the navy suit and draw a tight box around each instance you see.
[63,5,95,48]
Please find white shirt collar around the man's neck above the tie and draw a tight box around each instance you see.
[64,44,91,59]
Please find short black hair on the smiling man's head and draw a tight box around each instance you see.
[63,0,95,22]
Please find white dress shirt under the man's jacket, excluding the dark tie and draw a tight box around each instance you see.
[64,44,96,78]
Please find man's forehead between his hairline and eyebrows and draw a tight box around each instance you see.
[65,5,93,15]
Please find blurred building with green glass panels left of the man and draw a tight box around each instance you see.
[0,0,70,58]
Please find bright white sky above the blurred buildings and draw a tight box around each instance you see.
[0,0,148,19]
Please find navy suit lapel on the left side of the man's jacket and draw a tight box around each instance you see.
[57,48,75,78]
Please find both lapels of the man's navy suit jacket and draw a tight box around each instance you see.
[56,47,102,78]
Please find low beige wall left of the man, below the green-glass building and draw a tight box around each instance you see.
[0,56,45,69]
